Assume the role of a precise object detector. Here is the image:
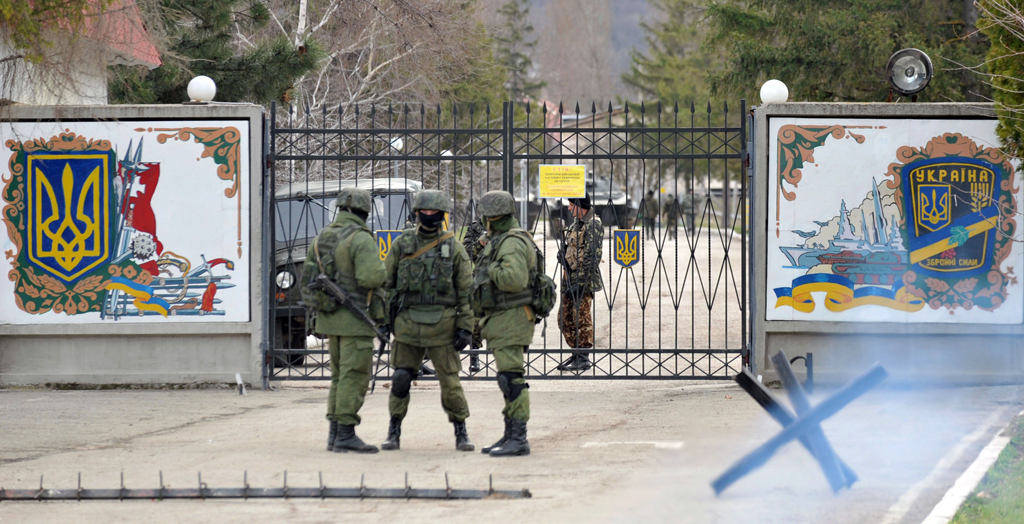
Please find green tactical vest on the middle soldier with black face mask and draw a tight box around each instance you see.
[395,231,458,309]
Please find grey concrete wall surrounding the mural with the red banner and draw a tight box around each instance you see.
[0,104,267,385]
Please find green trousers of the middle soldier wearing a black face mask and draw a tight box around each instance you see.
[388,342,469,422]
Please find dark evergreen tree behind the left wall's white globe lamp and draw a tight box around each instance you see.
[110,0,324,103]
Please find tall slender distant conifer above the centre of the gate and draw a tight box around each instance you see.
[495,0,547,100]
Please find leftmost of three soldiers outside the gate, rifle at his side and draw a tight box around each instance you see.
[300,187,386,453]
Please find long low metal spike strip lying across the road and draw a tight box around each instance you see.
[6,471,534,503]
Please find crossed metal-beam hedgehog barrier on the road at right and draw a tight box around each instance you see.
[712,351,889,495]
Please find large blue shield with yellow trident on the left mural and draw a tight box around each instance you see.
[26,151,116,282]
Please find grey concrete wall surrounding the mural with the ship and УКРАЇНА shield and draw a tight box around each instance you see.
[751,103,1024,384]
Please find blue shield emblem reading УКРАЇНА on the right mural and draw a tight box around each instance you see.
[903,157,1001,277]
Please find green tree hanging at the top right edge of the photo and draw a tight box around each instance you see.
[978,0,1024,158]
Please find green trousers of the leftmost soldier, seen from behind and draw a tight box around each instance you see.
[327,335,374,426]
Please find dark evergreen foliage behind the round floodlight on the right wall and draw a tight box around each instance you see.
[706,0,988,101]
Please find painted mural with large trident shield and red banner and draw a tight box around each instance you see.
[0,121,250,323]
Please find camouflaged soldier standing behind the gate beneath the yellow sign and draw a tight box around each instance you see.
[558,195,604,372]
